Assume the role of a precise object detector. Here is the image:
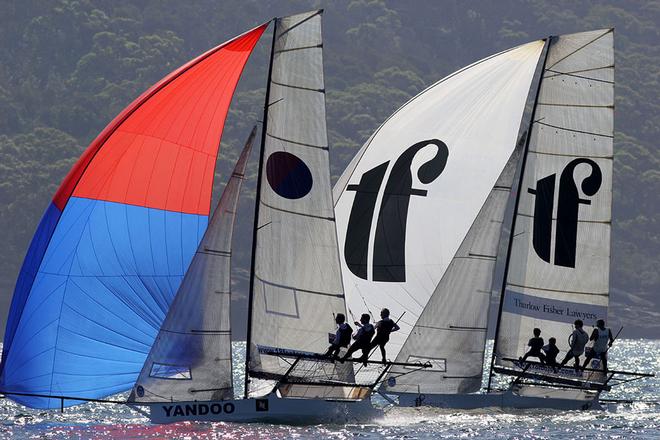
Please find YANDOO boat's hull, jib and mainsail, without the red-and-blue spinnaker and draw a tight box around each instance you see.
[129,11,402,423]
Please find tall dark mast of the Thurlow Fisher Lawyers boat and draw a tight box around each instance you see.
[486,36,554,393]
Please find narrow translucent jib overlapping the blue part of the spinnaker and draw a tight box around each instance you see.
[129,127,256,402]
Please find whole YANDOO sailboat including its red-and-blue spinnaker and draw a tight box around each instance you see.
[0,11,426,423]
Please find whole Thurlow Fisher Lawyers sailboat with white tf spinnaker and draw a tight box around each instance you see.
[335,29,644,409]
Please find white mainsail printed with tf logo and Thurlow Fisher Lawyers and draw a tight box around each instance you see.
[496,30,614,366]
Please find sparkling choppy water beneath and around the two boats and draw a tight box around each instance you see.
[0,340,660,440]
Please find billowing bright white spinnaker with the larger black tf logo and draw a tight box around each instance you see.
[335,41,544,358]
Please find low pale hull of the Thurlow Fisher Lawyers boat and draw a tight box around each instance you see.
[396,386,603,410]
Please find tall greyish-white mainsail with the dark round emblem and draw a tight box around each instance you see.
[248,12,352,395]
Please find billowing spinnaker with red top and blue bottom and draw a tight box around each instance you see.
[0,24,267,408]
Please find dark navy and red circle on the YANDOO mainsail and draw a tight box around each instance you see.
[266,151,313,199]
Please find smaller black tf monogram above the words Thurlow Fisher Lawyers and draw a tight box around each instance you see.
[527,158,603,267]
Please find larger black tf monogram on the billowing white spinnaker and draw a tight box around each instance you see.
[344,139,449,282]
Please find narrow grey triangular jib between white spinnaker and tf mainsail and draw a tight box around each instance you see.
[383,142,526,394]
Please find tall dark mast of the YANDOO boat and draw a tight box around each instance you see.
[243,18,277,399]
